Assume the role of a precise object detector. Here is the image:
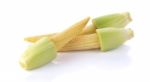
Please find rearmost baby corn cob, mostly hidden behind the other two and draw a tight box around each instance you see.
[24,12,131,43]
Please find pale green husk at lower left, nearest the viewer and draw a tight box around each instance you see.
[19,37,56,70]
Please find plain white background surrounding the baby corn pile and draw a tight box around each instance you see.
[0,0,150,82]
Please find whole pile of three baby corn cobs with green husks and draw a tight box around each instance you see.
[20,12,133,69]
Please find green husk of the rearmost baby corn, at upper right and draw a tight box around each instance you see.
[92,12,132,28]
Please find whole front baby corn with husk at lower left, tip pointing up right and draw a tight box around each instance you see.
[19,17,89,70]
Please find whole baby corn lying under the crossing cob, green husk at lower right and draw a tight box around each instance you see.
[59,28,133,51]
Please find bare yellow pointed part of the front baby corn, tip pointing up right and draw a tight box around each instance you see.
[50,17,90,50]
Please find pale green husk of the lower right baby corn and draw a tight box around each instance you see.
[96,28,133,51]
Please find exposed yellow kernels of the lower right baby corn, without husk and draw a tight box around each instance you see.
[59,33,100,51]
